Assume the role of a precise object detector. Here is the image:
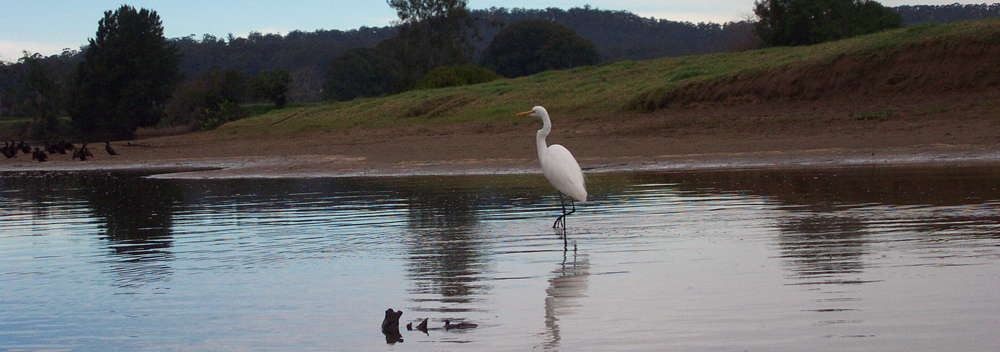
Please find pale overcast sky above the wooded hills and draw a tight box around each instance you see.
[0,0,982,61]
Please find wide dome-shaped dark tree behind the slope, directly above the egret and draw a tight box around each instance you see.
[483,20,600,77]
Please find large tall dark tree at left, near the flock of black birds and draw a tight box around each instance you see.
[69,5,180,139]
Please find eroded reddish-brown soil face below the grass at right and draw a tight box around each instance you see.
[630,38,1000,110]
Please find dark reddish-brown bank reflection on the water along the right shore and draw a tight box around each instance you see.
[656,166,1000,210]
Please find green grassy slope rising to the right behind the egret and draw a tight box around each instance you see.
[217,19,1000,135]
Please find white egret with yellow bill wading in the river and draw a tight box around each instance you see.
[517,106,587,230]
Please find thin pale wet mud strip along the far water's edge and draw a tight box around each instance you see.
[0,146,1000,180]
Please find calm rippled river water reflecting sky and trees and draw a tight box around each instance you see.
[0,167,1000,351]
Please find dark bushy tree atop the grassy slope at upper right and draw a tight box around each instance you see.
[754,0,901,46]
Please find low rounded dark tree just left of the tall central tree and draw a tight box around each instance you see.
[325,48,401,101]
